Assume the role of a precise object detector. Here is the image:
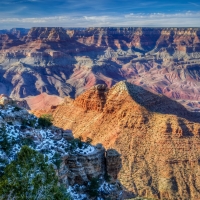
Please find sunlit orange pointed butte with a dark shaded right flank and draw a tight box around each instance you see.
[50,82,200,200]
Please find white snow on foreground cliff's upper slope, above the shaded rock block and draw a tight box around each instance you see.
[0,105,95,167]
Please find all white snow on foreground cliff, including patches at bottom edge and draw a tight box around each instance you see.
[0,106,119,200]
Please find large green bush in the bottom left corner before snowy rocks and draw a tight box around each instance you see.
[0,146,69,200]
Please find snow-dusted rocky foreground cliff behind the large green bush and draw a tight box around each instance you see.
[0,95,123,200]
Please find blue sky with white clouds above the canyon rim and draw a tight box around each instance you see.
[0,0,200,29]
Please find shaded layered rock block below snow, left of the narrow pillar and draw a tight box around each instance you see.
[59,145,105,185]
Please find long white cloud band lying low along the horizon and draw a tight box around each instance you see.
[0,11,200,29]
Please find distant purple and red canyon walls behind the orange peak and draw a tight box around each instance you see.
[0,27,200,111]
